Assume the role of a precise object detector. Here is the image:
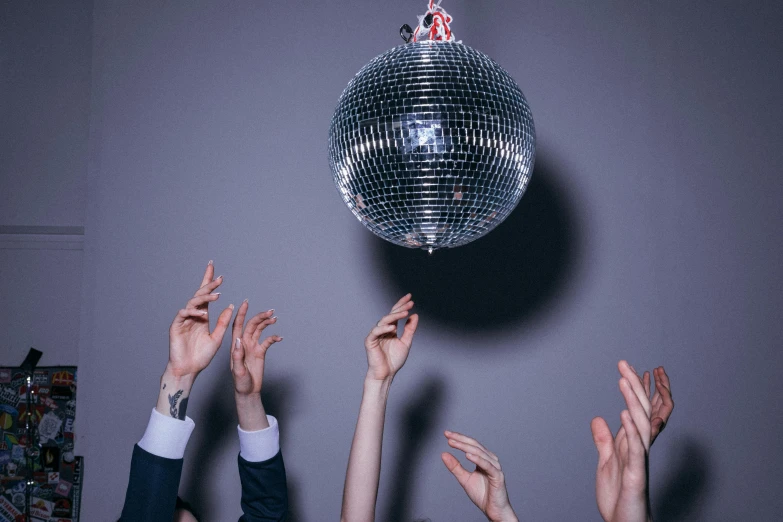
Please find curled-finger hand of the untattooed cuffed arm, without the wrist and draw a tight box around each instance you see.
[231,300,283,395]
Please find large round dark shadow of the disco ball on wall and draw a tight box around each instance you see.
[368,154,580,342]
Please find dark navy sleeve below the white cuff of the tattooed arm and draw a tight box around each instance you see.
[120,444,184,522]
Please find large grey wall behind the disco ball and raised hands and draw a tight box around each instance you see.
[6,0,783,521]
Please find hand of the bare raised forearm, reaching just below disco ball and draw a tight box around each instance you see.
[364,294,419,381]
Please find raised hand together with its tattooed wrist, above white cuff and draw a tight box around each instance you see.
[155,261,234,419]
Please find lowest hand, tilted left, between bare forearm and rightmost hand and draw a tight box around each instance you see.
[441,431,518,522]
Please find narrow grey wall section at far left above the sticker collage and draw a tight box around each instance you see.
[0,0,92,366]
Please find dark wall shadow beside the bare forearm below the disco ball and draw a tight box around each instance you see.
[379,376,446,522]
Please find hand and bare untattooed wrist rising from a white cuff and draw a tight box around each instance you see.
[231,299,283,431]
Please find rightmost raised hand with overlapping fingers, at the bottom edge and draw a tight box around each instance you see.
[591,361,674,521]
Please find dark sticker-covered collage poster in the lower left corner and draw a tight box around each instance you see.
[0,366,84,522]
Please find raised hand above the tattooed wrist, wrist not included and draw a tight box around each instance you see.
[167,261,234,378]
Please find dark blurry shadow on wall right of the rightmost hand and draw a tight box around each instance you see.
[653,437,711,522]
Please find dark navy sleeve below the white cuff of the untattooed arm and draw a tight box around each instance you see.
[239,451,288,522]
